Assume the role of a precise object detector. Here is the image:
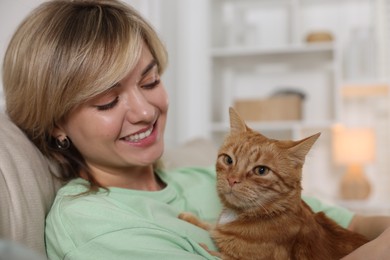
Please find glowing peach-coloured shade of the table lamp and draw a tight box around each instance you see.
[333,126,375,165]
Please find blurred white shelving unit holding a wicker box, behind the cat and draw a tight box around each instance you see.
[210,0,348,139]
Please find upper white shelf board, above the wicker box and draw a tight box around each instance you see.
[211,43,336,58]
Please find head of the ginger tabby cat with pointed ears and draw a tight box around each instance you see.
[216,108,320,212]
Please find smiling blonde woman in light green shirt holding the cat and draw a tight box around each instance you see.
[3,0,388,259]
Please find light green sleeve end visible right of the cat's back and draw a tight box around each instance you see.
[302,196,354,228]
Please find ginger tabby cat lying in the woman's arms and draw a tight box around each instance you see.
[179,108,368,260]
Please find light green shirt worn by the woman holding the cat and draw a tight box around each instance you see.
[45,168,353,260]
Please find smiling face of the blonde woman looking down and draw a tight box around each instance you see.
[55,45,168,175]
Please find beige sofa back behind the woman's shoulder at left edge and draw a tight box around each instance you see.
[0,113,59,253]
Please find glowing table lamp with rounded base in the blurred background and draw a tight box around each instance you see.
[333,126,375,200]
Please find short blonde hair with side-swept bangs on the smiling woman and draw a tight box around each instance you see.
[3,0,167,185]
